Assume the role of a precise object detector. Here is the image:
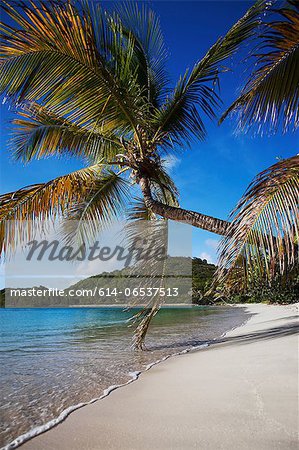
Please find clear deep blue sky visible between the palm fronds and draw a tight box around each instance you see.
[0,0,299,261]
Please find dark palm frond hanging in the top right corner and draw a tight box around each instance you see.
[221,2,299,133]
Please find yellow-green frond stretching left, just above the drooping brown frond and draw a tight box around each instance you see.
[10,103,122,163]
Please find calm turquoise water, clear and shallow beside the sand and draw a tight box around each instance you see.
[0,307,245,446]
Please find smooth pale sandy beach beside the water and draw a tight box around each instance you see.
[22,305,298,450]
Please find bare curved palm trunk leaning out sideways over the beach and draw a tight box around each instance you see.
[139,177,230,236]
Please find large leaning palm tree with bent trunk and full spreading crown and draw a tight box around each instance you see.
[0,0,267,255]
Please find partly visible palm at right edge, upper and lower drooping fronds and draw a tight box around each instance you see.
[215,1,299,294]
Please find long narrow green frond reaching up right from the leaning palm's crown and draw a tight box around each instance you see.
[155,0,268,146]
